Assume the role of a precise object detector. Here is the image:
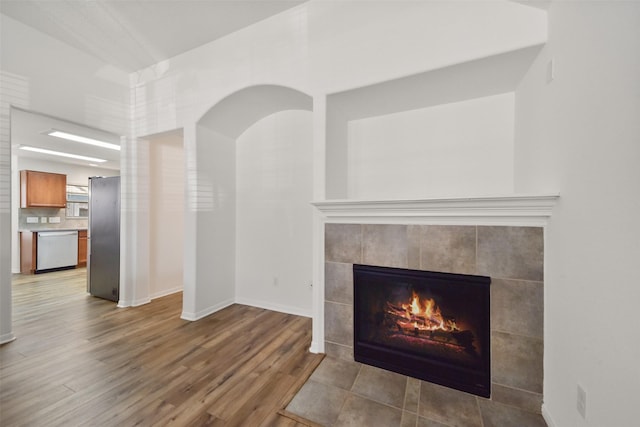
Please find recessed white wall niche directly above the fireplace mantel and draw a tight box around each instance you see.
[326,46,540,200]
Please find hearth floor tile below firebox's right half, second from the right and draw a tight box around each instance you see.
[418,382,482,427]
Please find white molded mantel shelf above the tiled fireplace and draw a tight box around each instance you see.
[311,193,560,226]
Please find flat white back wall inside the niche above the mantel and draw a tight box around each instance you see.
[347,93,514,200]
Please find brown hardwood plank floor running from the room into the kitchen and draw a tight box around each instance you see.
[0,269,322,427]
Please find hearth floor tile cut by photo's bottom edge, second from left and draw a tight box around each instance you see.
[334,394,402,427]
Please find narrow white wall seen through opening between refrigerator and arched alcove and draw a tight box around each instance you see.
[146,131,185,299]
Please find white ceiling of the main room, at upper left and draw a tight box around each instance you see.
[0,0,306,72]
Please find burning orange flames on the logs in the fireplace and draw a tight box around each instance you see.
[391,291,459,332]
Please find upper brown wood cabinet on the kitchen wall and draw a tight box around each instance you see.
[20,170,67,208]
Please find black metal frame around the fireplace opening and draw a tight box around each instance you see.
[353,264,491,397]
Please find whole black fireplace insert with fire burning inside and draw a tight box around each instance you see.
[353,264,491,397]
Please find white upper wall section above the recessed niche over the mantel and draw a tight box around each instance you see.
[301,0,546,93]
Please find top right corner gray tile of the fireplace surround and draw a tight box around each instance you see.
[477,227,544,282]
